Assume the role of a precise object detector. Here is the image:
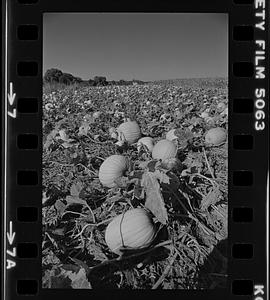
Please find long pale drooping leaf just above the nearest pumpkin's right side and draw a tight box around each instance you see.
[141,172,168,224]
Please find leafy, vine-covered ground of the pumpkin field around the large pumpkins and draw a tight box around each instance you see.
[42,79,228,289]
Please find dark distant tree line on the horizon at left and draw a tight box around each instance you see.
[43,68,146,86]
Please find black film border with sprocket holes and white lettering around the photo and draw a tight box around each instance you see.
[2,0,269,299]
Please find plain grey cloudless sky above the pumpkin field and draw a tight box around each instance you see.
[43,13,228,81]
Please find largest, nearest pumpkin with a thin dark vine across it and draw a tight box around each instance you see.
[105,208,156,255]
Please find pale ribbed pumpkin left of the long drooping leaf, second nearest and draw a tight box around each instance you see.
[98,155,127,188]
